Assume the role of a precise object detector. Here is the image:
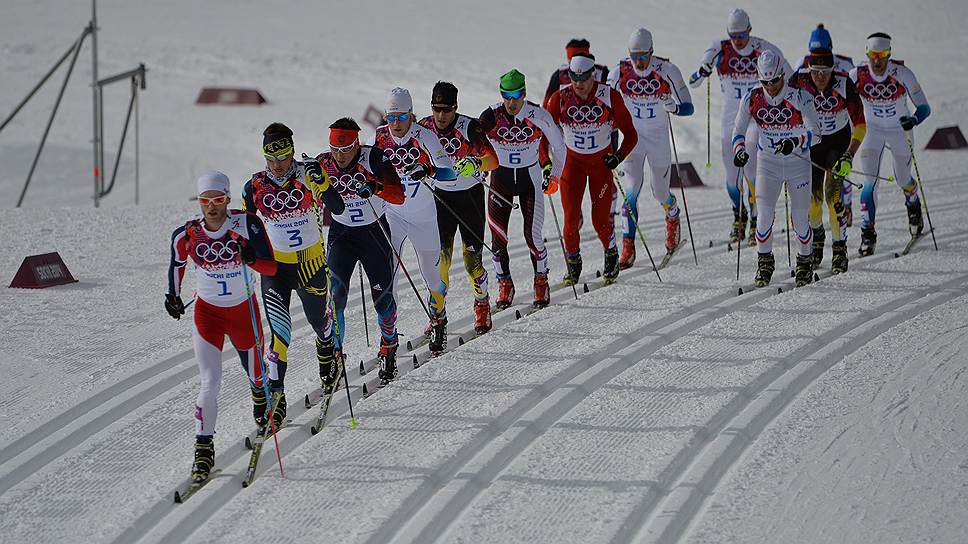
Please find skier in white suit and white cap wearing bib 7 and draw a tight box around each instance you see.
[369,87,457,353]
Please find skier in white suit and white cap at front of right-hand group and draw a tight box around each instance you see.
[733,51,820,287]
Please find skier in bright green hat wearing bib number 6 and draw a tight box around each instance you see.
[480,69,566,310]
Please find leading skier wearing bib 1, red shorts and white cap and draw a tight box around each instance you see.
[165,171,277,482]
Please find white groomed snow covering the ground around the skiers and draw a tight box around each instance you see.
[0,0,968,543]
